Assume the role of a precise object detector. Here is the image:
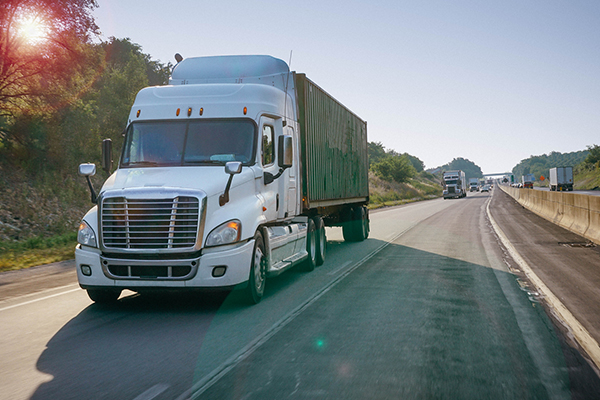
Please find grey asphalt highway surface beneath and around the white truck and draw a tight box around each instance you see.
[0,189,600,400]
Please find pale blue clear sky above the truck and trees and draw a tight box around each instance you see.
[93,0,600,174]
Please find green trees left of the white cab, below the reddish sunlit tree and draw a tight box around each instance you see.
[0,38,169,176]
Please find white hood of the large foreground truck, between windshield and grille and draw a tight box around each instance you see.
[102,166,254,197]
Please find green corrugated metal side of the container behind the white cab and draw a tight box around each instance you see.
[295,74,369,208]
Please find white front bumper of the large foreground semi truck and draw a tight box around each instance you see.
[75,240,254,291]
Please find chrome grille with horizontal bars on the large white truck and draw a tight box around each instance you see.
[101,196,200,250]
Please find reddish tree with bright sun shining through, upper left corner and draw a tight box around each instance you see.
[0,0,98,118]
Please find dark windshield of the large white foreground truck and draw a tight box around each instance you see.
[121,119,256,167]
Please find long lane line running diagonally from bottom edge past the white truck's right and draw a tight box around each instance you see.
[177,222,419,400]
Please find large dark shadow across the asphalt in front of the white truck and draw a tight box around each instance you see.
[32,239,600,399]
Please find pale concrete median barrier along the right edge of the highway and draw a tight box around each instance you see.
[498,185,600,244]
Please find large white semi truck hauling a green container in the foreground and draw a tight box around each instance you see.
[75,56,370,303]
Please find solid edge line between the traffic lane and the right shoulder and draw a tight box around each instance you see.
[487,193,600,368]
